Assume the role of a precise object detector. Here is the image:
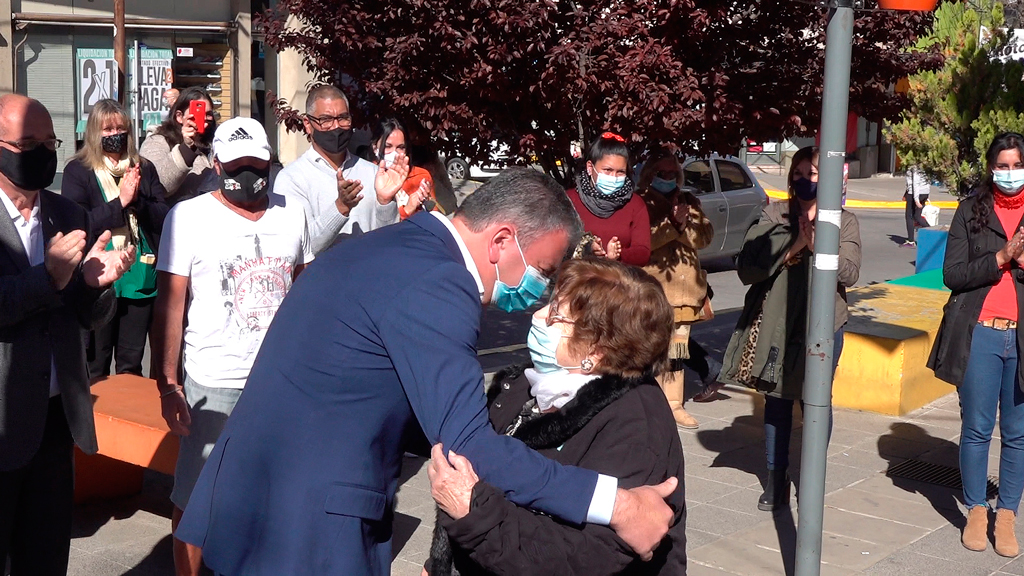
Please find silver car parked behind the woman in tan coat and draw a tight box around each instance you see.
[682,155,768,259]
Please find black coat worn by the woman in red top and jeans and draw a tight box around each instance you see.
[928,195,1024,387]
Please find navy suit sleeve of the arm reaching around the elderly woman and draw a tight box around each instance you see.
[378,262,597,524]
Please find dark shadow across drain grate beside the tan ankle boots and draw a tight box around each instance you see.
[878,422,967,530]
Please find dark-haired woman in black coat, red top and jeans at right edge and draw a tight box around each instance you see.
[928,132,1024,557]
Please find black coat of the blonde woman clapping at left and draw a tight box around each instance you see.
[60,158,170,253]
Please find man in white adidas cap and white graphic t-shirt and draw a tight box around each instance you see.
[151,118,313,574]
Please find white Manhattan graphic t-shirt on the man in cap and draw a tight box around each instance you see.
[157,193,313,388]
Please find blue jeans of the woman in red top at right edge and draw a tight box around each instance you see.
[957,325,1024,512]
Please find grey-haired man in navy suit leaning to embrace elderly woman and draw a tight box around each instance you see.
[176,168,676,576]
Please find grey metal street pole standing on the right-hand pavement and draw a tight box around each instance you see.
[796,0,853,576]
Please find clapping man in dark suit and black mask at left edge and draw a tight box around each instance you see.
[0,94,134,576]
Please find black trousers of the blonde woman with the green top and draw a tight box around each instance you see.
[87,298,156,380]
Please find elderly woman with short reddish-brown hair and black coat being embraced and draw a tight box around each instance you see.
[426,259,686,576]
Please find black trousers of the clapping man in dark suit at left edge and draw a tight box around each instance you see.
[0,396,75,576]
